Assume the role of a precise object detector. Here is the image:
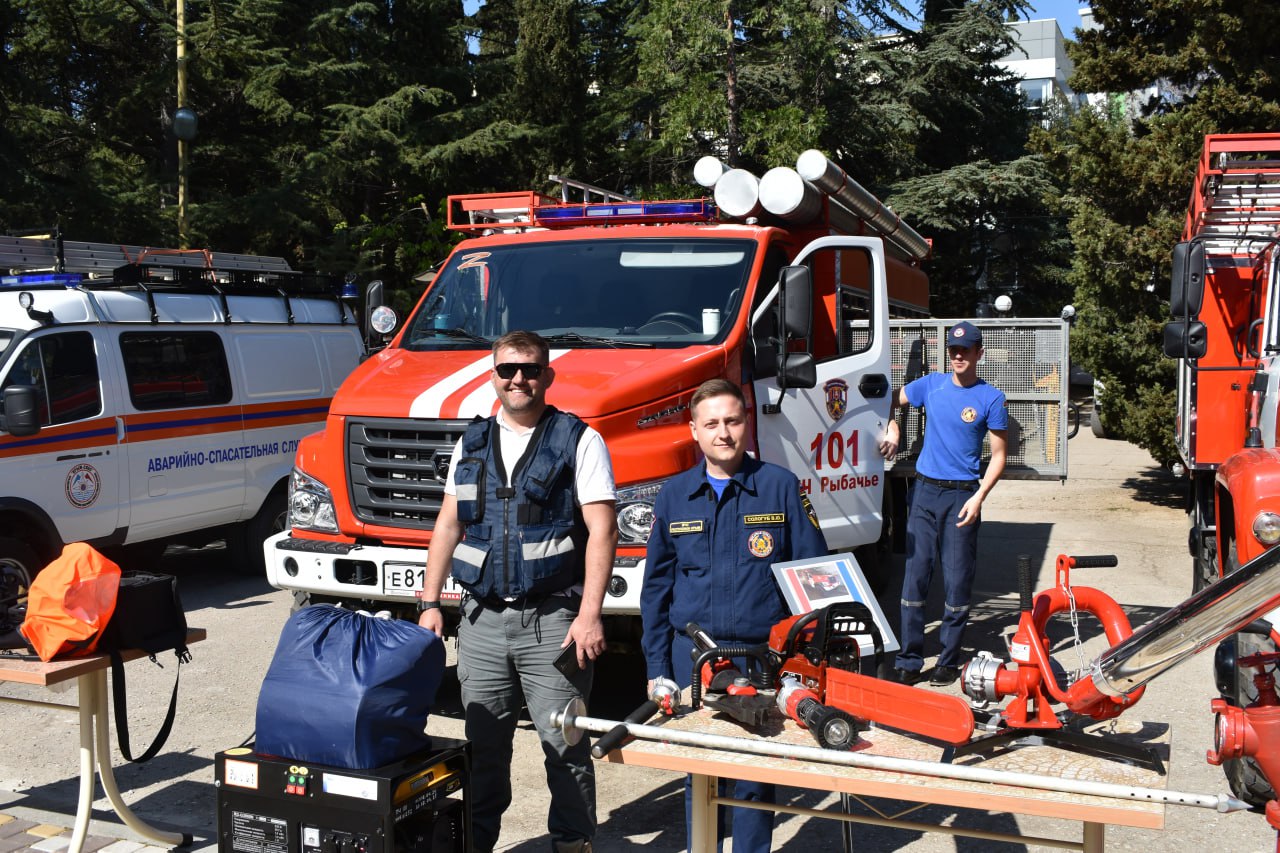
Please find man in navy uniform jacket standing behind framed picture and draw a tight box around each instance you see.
[640,379,827,853]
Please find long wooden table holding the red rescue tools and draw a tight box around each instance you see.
[608,708,1170,853]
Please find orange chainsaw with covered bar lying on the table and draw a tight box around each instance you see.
[769,602,974,744]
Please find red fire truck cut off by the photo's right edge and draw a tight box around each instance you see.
[1164,133,1280,803]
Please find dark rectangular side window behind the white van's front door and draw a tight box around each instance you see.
[120,332,232,411]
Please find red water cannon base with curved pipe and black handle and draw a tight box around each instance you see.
[956,555,1164,772]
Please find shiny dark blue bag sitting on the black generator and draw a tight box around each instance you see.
[253,605,444,770]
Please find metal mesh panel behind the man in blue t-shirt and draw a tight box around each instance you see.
[890,319,1070,480]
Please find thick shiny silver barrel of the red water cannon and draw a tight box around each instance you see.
[1089,540,1280,697]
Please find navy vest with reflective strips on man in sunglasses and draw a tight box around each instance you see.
[453,406,586,598]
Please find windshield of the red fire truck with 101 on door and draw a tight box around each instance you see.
[402,238,755,350]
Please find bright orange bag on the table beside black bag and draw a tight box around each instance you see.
[20,542,120,661]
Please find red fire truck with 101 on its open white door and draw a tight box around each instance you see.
[265,151,929,643]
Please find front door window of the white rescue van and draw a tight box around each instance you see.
[4,332,102,427]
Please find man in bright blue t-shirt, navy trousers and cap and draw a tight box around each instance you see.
[879,321,1009,685]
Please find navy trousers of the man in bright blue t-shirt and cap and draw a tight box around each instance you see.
[895,480,982,672]
